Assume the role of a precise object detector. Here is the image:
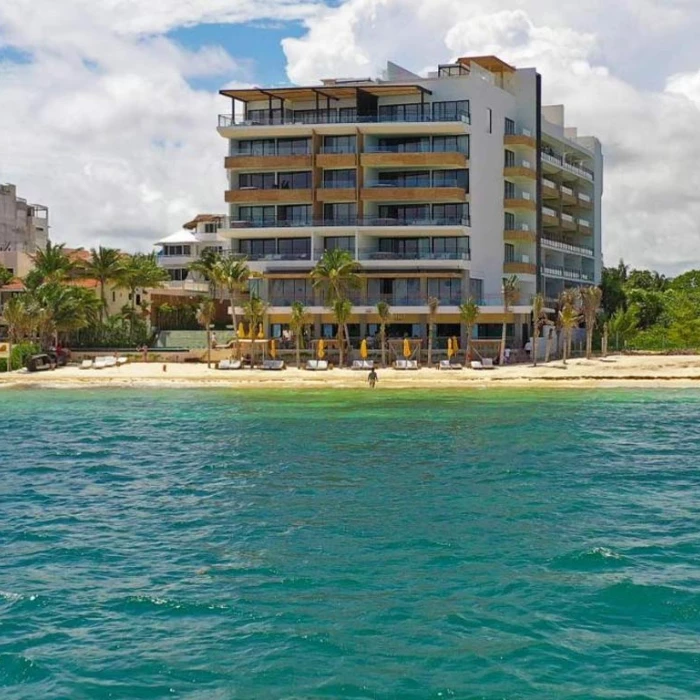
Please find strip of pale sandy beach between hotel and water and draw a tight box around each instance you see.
[0,355,700,390]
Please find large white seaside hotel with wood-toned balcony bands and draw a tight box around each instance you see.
[213,56,603,343]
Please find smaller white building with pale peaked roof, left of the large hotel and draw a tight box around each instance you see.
[155,214,230,293]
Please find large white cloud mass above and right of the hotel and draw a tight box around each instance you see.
[283,0,700,272]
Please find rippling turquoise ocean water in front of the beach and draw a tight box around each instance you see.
[0,389,700,700]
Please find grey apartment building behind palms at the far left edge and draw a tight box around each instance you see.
[0,184,49,276]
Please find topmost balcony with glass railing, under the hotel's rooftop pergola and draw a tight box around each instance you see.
[218,110,471,129]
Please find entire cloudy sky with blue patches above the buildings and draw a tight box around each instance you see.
[0,0,700,274]
